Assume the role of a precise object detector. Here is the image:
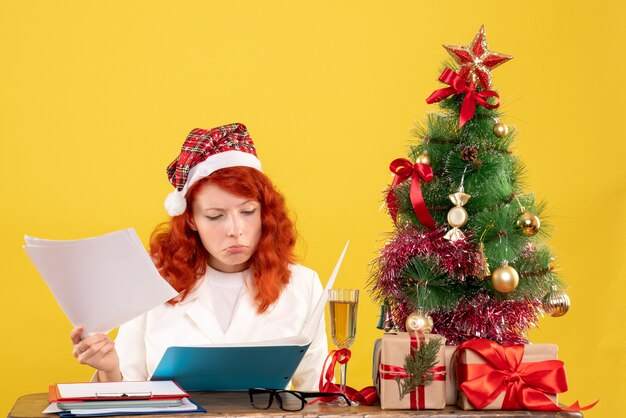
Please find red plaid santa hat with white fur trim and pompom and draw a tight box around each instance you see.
[165,123,261,216]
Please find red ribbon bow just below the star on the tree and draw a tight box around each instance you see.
[426,68,500,128]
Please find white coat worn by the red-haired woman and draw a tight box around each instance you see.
[115,264,328,391]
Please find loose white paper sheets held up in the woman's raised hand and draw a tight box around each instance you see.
[24,228,177,334]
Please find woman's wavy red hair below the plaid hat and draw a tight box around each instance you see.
[150,167,297,313]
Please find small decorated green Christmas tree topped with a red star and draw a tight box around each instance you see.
[369,27,569,344]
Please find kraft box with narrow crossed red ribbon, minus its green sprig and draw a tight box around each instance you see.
[374,332,446,409]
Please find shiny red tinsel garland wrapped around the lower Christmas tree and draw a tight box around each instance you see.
[370,226,541,345]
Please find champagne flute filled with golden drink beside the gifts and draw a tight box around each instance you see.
[328,289,359,402]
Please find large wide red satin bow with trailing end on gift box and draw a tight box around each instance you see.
[456,338,598,412]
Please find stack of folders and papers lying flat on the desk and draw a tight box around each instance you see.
[43,380,206,417]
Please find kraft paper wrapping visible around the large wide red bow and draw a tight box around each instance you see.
[455,342,564,410]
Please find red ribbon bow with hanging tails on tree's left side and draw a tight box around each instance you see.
[387,158,436,229]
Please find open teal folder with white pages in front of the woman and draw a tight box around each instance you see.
[152,243,348,391]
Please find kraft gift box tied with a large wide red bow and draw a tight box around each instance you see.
[453,339,567,410]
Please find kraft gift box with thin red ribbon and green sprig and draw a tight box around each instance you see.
[374,332,446,409]
